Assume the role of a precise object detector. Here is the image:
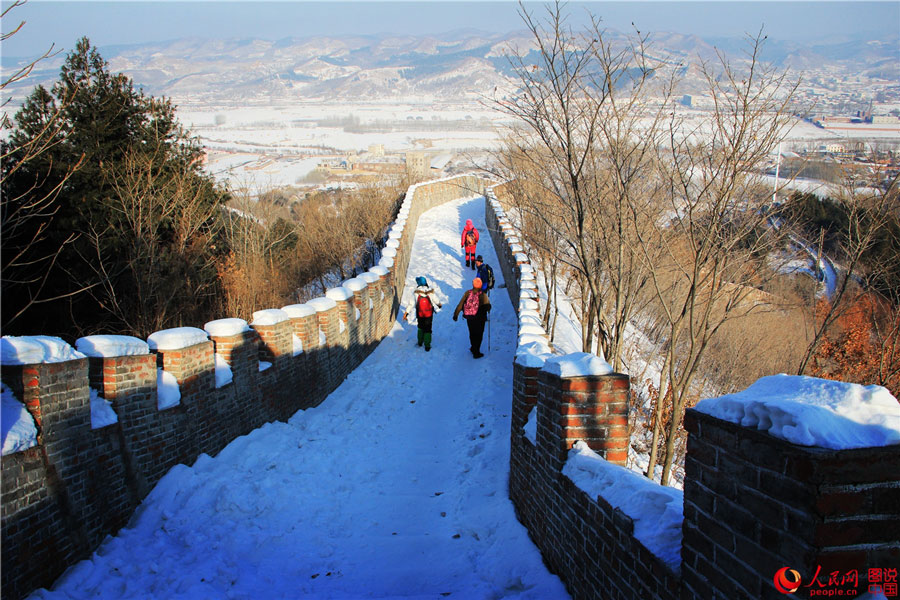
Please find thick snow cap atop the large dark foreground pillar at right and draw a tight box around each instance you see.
[695,374,900,450]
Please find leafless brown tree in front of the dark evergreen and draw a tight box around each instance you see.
[82,147,219,337]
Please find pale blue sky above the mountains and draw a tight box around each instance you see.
[0,0,900,56]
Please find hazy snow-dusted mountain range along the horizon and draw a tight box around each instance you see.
[3,30,900,103]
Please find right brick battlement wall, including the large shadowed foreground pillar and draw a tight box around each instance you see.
[485,185,900,600]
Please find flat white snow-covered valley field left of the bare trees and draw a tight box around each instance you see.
[178,102,510,190]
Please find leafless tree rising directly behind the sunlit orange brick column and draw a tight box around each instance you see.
[496,3,674,369]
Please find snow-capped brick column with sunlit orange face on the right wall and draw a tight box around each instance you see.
[537,353,629,469]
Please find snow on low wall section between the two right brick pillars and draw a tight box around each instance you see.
[563,441,684,572]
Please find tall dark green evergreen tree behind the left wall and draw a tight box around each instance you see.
[2,38,224,337]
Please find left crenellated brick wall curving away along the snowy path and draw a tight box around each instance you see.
[2,175,485,598]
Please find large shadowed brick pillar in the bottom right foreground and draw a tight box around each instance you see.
[682,409,900,599]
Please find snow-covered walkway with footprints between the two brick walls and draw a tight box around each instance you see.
[34,198,568,600]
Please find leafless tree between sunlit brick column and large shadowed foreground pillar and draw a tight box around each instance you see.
[635,34,798,484]
